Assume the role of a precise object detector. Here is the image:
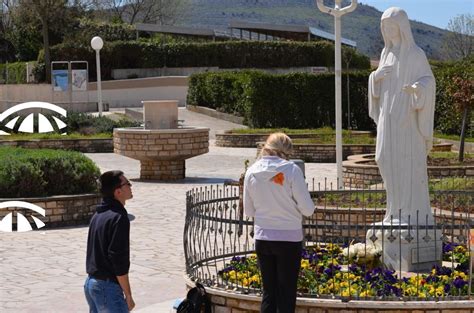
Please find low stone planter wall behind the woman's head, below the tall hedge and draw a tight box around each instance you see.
[216,131,372,148]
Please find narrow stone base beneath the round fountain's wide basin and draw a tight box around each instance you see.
[140,160,185,180]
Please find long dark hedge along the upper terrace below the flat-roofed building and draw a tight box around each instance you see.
[38,41,370,79]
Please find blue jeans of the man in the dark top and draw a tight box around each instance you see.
[84,276,129,313]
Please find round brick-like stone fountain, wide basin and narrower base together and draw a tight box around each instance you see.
[114,127,209,180]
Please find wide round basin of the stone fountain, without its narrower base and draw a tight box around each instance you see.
[114,127,209,161]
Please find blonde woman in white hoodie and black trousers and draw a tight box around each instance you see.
[244,133,314,313]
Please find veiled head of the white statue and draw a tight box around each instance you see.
[380,7,414,47]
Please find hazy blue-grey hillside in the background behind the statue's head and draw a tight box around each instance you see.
[178,0,447,59]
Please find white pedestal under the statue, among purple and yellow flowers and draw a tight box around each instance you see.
[367,225,443,272]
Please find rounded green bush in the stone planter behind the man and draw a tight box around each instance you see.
[0,147,100,198]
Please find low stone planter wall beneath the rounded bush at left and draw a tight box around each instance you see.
[0,194,101,228]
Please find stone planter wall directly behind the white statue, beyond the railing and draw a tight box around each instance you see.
[342,154,474,187]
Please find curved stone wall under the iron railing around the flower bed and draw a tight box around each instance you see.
[185,276,474,313]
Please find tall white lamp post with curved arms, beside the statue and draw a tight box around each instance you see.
[316,0,357,189]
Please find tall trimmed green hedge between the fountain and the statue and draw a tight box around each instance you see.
[187,71,375,130]
